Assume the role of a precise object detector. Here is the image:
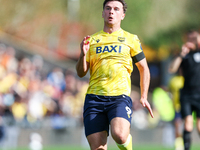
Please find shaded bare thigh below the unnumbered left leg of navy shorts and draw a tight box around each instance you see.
[87,131,108,150]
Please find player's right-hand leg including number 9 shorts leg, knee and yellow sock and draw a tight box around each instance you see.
[107,95,132,150]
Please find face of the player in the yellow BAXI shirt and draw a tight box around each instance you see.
[102,1,125,26]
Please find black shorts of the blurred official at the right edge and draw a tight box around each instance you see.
[180,91,200,119]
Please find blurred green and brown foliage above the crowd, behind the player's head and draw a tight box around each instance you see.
[0,0,200,59]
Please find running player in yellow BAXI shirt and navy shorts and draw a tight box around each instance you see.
[76,0,153,150]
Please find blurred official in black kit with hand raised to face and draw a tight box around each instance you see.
[170,31,200,150]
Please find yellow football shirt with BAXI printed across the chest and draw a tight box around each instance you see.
[86,28,145,96]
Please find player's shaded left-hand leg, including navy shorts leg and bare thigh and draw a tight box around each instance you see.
[83,95,109,150]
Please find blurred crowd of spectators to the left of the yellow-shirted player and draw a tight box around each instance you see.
[0,43,88,149]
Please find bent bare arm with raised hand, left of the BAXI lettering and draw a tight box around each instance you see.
[76,36,90,77]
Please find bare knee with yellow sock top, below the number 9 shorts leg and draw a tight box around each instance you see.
[111,117,132,150]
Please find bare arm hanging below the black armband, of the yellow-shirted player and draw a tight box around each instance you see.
[135,58,154,118]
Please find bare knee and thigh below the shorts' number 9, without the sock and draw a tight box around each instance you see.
[110,117,130,144]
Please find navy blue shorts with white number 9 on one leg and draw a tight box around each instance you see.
[83,94,132,136]
